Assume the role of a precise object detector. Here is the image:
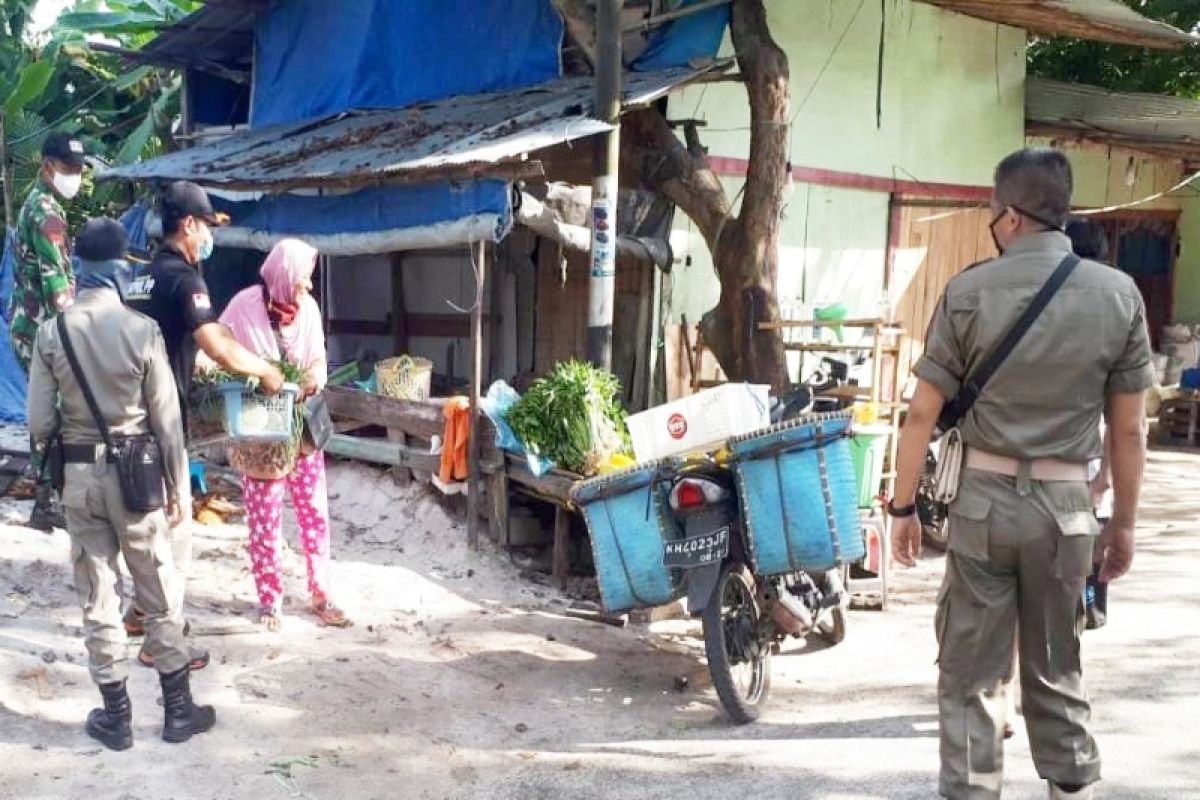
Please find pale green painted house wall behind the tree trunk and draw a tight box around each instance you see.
[670,0,1026,320]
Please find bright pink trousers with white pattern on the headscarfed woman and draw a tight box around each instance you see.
[241,452,329,614]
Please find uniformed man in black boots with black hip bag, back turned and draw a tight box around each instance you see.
[29,219,216,750]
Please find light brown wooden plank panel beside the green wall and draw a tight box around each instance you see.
[890,200,996,383]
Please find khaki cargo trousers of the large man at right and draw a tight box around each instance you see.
[936,470,1100,800]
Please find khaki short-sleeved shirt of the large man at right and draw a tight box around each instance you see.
[916,233,1154,463]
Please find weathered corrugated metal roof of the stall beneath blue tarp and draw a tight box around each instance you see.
[100,60,732,190]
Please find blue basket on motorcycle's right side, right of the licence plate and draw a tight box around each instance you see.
[730,413,866,576]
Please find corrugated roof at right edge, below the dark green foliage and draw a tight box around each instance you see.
[1025,78,1200,157]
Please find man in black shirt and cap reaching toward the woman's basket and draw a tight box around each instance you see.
[126,181,283,667]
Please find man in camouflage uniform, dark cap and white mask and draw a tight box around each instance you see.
[8,133,85,531]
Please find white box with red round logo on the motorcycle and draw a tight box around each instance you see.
[629,384,770,462]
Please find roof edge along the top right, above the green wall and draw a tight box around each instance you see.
[924,0,1198,49]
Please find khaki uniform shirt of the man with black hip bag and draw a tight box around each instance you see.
[29,289,191,500]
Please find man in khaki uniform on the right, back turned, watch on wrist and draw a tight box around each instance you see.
[889,150,1153,800]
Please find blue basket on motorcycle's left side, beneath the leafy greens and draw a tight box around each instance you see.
[571,462,683,613]
